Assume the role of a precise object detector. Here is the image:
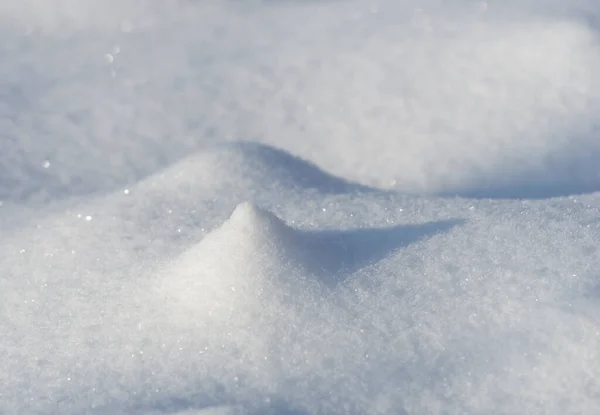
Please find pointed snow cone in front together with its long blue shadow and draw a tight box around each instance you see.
[161,202,462,307]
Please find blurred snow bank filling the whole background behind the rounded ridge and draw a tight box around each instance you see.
[0,1,600,199]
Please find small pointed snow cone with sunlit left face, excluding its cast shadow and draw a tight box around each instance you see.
[161,203,304,304]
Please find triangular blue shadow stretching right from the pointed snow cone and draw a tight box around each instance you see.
[303,219,465,285]
